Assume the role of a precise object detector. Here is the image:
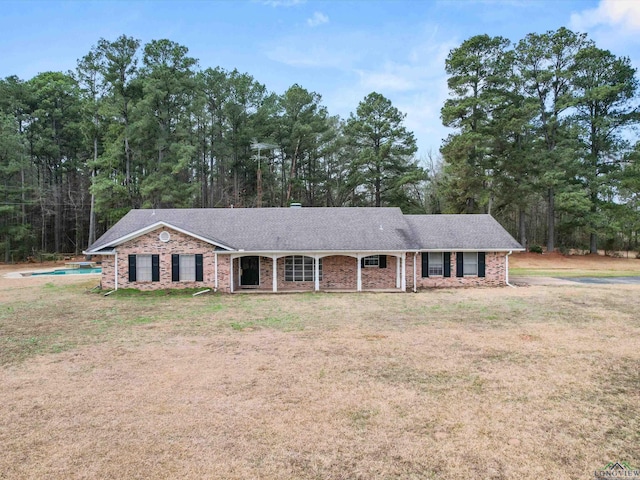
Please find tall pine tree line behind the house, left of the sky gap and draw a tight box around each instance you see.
[0,35,426,261]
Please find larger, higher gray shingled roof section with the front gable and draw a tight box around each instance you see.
[90,208,411,251]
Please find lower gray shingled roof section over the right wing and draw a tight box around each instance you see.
[405,215,522,251]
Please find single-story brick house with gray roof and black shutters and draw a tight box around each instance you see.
[84,207,523,293]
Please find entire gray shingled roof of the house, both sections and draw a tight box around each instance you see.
[87,207,521,252]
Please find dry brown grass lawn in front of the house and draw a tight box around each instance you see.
[0,279,640,479]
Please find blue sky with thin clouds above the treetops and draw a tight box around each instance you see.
[0,0,640,157]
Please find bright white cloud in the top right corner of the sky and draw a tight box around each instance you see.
[569,0,640,33]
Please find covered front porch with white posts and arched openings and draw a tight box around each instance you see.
[230,252,407,293]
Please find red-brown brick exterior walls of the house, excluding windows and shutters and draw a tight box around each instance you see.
[94,228,506,293]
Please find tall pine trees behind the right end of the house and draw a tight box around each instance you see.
[438,28,640,253]
